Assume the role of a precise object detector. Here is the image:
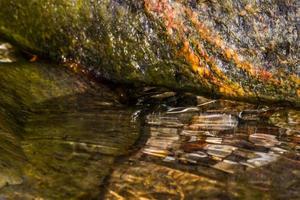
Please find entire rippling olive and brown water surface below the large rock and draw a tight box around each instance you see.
[0,40,300,199]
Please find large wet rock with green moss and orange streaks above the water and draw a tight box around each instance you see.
[0,0,300,106]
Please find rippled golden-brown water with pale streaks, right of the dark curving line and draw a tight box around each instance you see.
[106,98,300,199]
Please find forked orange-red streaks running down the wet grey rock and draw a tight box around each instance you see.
[144,0,299,96]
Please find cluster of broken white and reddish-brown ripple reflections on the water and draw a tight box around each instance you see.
[142,104,297,171]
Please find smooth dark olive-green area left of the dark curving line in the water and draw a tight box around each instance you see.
[0,44,139,200]
